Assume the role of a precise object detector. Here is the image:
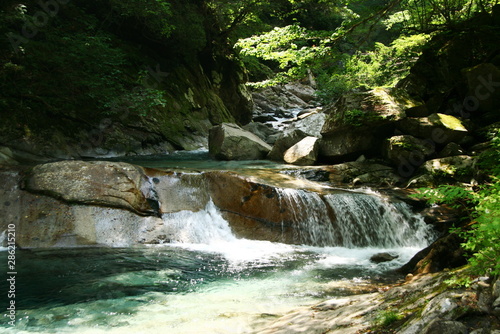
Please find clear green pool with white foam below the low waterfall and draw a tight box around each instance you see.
[0,240,417,334]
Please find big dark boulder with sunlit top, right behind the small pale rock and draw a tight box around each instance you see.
[320,88,417,162]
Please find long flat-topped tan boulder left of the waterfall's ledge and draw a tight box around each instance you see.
[24,161,155,215]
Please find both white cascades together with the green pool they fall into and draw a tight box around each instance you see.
[0,167,438,334]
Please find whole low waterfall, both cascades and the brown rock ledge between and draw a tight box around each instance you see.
[143,173,434,248]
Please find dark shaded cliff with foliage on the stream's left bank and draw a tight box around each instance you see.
[0,0,252,161]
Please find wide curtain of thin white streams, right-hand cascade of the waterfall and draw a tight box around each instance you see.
[279,189,434,248]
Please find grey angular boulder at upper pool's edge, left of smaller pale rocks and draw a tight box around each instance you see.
[208,123,271,160]
